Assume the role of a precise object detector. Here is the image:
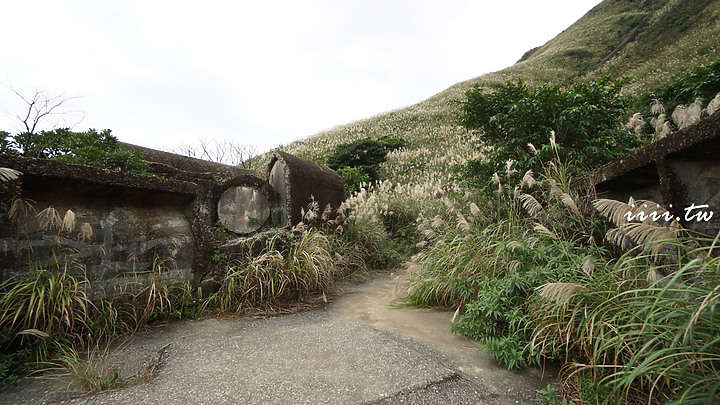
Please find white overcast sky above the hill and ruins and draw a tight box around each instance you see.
[0,0,600,155]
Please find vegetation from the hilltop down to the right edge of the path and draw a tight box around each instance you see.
[264,0,720,403]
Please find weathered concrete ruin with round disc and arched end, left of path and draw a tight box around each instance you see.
[0,144,344,297]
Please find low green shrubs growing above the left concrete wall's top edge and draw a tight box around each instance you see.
[0,128,150,174]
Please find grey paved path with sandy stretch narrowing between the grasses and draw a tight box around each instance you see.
[0,264,547,404]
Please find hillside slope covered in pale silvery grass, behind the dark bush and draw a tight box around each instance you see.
[272,0,720,174]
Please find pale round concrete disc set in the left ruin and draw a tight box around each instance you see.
[218,186,270,233]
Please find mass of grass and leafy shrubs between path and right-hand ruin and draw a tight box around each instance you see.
[408,141,720,403]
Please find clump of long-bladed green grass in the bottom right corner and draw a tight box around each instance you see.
[534,245,720,403]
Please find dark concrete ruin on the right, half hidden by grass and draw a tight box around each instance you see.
[586,111,720,236]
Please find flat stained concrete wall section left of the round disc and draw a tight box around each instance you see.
[0,156,198,297]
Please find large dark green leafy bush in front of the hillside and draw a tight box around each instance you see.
[456,76,640,187]
